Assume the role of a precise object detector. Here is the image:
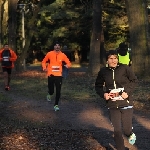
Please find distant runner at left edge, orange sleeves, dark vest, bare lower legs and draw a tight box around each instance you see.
[0,44,17,91]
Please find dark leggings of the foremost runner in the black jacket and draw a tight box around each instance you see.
[109,108,133,150]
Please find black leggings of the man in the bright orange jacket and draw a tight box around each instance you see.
[48,76,62,105]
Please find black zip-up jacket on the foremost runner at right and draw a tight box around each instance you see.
[95,64,137,108]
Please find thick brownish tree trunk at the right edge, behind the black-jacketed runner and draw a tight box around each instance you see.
[126,0,150,77]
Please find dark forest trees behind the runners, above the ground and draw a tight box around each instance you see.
[0,0,150,78]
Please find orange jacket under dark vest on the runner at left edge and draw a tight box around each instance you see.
[0,49,17,68]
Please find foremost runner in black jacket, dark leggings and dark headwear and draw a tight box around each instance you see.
[95,50,137,150]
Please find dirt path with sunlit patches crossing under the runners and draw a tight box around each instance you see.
[1,88,150,150]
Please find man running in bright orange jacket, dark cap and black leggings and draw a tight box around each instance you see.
[42,42,71,111]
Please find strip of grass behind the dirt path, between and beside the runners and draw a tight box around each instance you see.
[0,70,150,111]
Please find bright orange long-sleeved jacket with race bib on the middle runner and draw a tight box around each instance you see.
[42,50,71,76]
